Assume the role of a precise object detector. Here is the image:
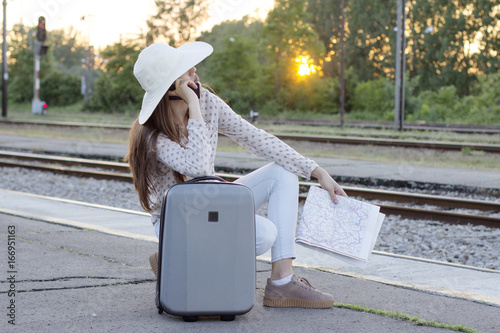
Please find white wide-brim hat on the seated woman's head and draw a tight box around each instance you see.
[134,42,213,125]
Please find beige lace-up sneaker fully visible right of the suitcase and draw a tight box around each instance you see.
[264,274,333,309]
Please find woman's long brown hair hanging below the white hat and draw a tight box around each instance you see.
[124,94,186,212]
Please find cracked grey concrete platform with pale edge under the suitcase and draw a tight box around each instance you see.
[0,190,500,332]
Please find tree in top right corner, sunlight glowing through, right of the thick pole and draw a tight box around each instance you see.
[407,0,500,96]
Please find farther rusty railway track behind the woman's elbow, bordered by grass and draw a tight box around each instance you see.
[0,120,500,153]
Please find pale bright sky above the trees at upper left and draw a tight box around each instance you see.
[7,0,274,48]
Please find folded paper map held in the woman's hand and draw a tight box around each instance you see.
[295,186,385,268]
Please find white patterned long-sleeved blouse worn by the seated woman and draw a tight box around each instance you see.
[149,88,318,223]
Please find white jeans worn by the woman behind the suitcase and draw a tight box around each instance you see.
[154,163,299,262]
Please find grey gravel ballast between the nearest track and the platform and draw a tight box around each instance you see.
[0,167,500,270]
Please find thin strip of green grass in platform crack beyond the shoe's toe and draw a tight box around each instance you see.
[333,303,477,333]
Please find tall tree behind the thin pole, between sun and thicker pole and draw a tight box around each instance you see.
[307,0,396,80]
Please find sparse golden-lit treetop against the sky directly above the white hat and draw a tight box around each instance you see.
[146,0,210,46]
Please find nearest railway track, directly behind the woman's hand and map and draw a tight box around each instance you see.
[0,151,500,228]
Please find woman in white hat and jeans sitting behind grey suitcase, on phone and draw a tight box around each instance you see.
[127,42,346,308]
